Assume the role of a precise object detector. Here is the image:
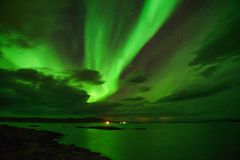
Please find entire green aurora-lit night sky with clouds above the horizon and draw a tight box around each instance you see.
[0,0,240,121]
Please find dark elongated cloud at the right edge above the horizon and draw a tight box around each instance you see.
[157,57,240,105]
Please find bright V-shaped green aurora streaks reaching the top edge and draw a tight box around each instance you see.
[84,0,178,102]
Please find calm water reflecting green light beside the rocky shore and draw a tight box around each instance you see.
[1,123,240,160]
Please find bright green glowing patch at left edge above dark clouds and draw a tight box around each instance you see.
[0,34,64,71]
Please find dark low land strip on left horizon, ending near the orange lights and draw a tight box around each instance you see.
[0,117,117,123]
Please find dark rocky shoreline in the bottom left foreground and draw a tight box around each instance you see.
[0,125,110,160]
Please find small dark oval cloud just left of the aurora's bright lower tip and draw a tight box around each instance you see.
[71,69,104,85]
